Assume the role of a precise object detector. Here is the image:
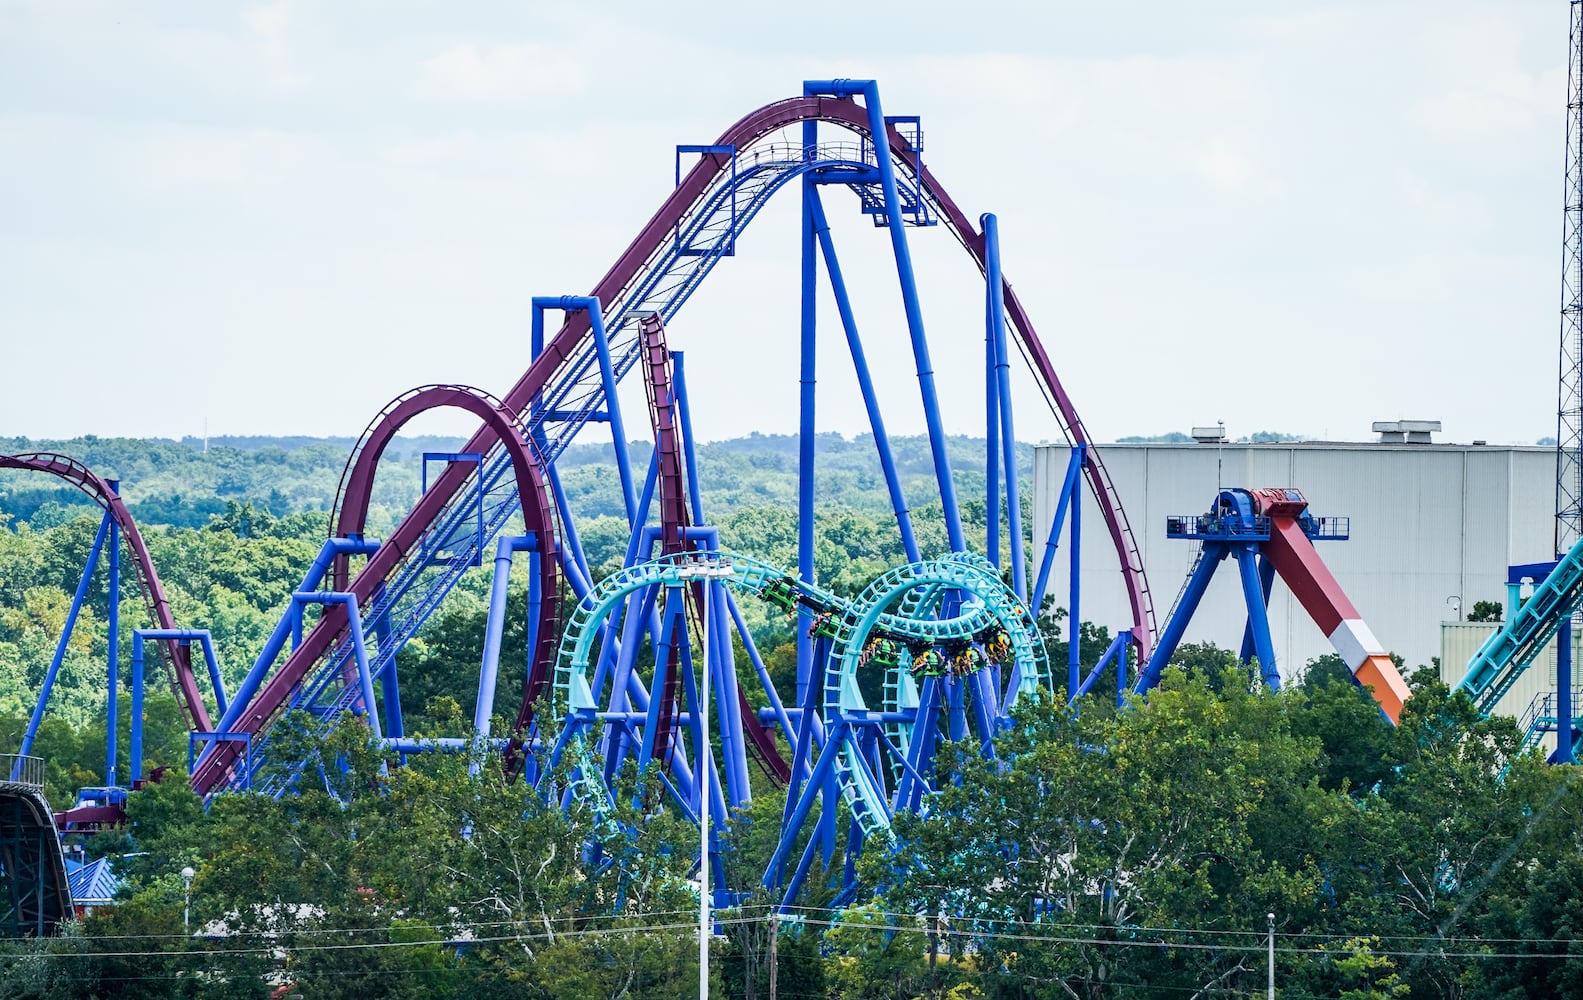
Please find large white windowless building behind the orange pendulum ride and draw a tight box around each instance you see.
[1034,422,1555,702]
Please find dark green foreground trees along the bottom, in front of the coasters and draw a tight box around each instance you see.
[0,646,1583,1000]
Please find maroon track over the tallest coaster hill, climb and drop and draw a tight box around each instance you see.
[192,95,1154,794]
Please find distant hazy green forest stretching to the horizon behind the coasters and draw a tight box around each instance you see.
[0,434,1032,750]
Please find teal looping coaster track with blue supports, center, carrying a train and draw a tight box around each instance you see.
[541,552,1050,900]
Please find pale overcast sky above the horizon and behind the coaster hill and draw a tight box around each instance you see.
[0,0,1567,443]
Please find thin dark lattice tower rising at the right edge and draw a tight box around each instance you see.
[1555,0,1583,557]
